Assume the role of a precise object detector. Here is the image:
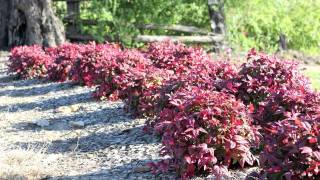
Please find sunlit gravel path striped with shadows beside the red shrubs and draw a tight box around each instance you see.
[0,53,258,179]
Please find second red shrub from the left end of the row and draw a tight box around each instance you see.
[46,43,85,82]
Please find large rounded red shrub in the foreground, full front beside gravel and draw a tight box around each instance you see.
[152,87,259,179]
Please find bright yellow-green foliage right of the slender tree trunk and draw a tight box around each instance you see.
[226,0,320,54]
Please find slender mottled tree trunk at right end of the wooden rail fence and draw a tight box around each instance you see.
[208,0,226,52]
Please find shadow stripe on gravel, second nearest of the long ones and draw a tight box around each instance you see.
[12,106,126,131]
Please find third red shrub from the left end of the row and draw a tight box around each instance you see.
[72,43,121,86]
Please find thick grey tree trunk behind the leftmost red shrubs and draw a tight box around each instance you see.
[0,0,65,47]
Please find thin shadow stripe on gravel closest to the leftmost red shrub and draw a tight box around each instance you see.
[0,79,75,97]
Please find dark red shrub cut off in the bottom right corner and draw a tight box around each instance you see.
[260,114,320,179]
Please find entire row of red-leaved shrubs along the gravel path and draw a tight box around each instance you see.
[9,41,320,179]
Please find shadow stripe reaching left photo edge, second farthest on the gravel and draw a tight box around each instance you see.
[0,92,94,112]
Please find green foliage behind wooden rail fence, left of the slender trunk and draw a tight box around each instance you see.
[75,0,210,46]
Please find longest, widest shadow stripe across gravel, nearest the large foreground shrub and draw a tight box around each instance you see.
[16,126,158,154]
